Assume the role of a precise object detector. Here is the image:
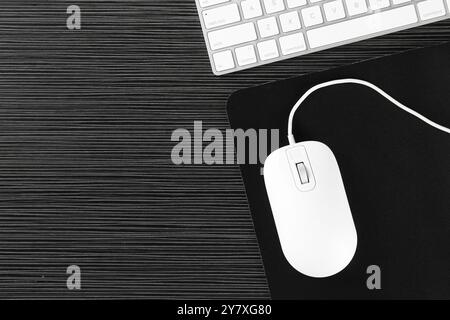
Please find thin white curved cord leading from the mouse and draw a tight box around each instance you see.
[288,79,450,144]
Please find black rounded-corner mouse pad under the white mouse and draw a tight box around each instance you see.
[228,44,450,299]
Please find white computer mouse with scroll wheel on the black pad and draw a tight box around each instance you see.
[264,141,357,278]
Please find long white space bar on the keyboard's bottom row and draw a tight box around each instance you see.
[307,5,418,48]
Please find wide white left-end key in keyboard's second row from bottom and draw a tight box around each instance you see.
[208,22,257,50]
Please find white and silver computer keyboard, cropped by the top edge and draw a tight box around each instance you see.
[196,0,450,75]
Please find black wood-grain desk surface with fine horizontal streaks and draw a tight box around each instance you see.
[0,0,450,299]
